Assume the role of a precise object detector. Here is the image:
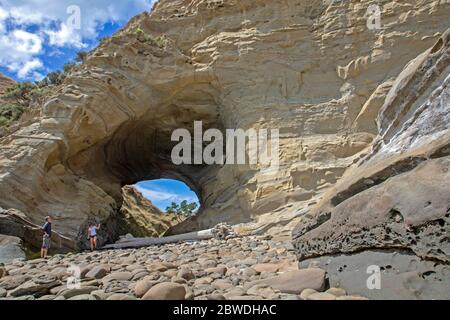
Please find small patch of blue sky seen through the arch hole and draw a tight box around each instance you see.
[135,179,199,211]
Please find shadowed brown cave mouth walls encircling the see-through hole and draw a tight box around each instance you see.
[67,84,225,242]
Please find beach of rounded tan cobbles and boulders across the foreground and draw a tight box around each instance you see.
[0,236,366,300]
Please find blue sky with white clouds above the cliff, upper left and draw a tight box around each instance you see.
[0,0,154,81]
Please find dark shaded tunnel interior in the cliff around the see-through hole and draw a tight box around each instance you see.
[64,100,222,248]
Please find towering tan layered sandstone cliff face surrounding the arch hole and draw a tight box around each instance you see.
[0,0,450,250]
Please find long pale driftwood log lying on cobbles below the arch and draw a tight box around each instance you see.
[102,223,236,249]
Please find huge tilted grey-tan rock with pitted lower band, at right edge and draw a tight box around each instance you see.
[293,31,450,299]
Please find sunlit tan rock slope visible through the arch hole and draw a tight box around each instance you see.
[119,186,184,237]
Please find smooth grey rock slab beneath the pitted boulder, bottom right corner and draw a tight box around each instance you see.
[300,250,450,300]
